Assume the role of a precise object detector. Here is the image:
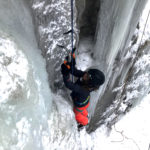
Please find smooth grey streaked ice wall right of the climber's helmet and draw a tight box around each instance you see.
[90,0,146,131]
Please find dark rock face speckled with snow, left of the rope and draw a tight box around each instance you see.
[31,0,75,92]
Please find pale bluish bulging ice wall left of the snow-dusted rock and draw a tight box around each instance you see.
[0,0,51,150]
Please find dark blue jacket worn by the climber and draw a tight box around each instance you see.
[63,67,90,107]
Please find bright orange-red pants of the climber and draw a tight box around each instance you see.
[73,103,90,126]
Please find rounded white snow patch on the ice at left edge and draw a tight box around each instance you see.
[0,38,29,103]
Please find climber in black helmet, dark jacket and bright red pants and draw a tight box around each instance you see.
[61,53,105,128]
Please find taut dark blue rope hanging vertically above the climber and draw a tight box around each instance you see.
[71,0,74,82]
